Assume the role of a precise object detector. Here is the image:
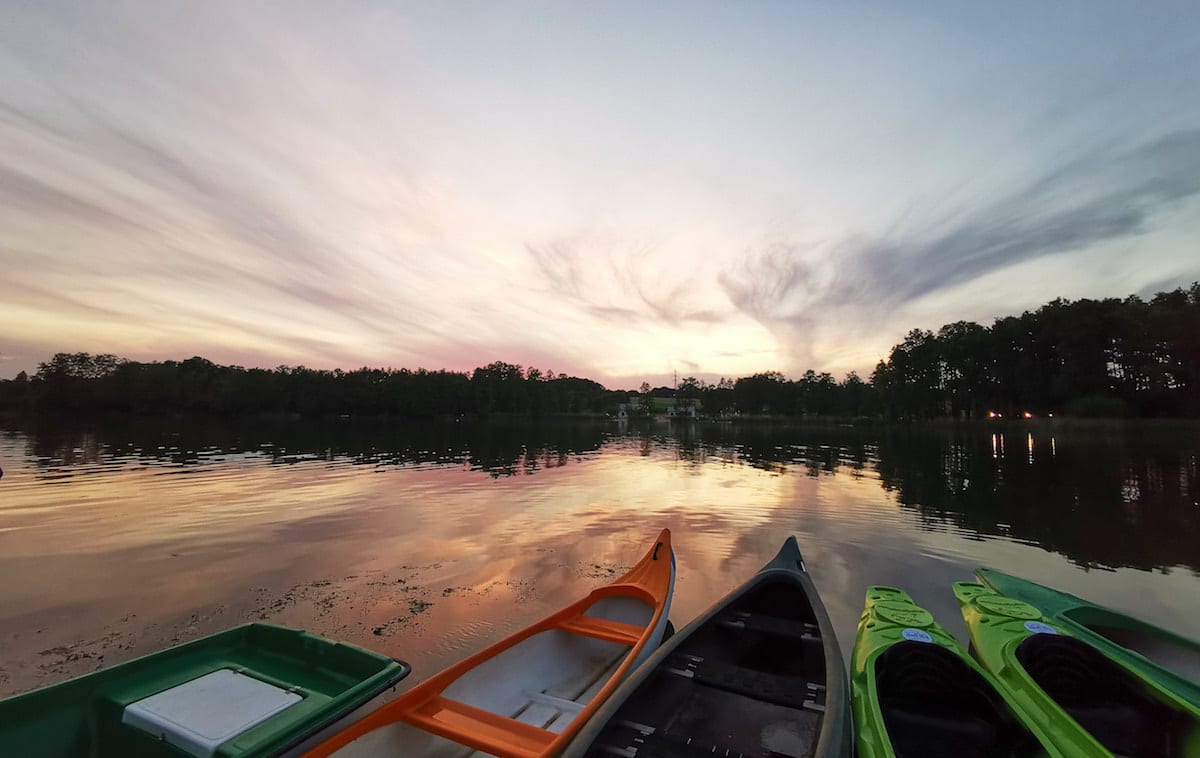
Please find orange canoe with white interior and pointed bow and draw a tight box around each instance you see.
[306,529,674,758]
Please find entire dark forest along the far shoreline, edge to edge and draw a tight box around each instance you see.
[0,282,1200,419]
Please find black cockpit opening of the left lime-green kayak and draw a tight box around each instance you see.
[875,642,1045,758]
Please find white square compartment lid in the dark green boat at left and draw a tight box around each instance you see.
[121,668,304,758]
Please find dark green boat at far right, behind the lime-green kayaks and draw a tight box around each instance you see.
[976,569,1200,706]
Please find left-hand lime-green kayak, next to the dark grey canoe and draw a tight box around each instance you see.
[851,586,1066,758]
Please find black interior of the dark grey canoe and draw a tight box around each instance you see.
[576,574,826,758]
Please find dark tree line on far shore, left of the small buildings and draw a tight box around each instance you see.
[0,353,624,417]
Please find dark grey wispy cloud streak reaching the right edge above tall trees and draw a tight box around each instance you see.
[721,131,1200,326]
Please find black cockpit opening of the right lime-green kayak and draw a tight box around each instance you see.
[1016,634,1200,758]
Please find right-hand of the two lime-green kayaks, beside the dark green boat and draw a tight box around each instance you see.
[954,582,1200,758]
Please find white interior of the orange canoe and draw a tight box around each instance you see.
[335,594,673,758]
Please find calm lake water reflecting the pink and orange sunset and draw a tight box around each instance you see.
[0,420,1200,696]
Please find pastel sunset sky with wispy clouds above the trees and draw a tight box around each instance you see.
[0,0,1200,387]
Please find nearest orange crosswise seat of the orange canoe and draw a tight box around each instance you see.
[403,697,558,758]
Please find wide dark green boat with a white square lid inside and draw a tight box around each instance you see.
[0,624,409,758]
